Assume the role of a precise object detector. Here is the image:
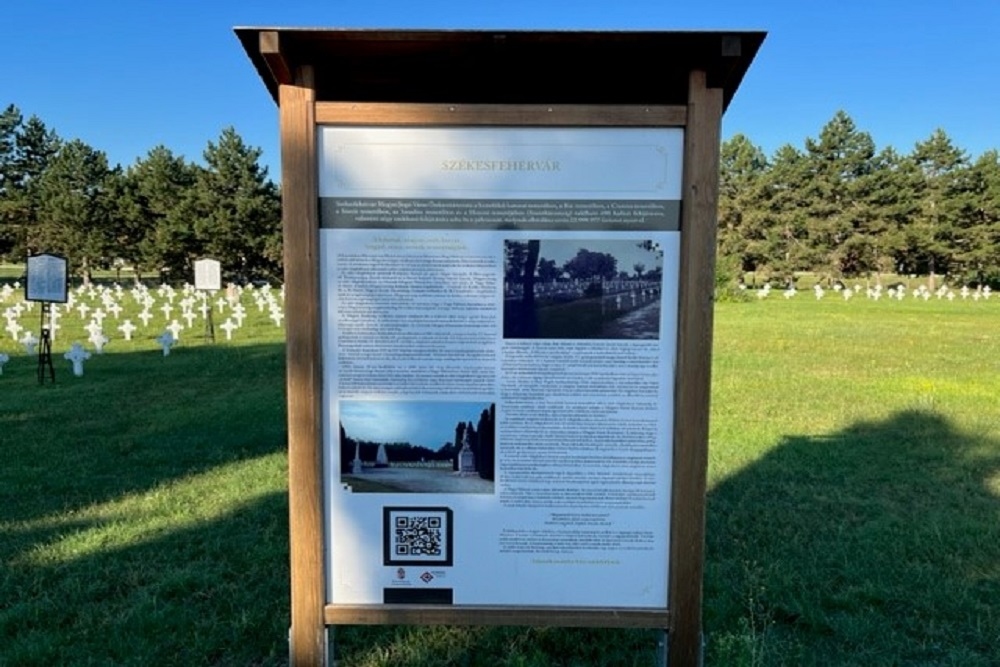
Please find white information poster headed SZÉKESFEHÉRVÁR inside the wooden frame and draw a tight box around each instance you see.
[318,127,683,609]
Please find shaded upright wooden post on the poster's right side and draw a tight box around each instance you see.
[668,70,722,667]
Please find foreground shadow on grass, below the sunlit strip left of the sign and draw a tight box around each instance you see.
[0,493,289,667]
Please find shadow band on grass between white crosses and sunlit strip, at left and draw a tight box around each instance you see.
[0,344,287,522]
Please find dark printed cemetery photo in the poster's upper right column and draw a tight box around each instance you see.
[503,239,663,339]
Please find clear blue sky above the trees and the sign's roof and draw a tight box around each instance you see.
[0,0,1000,179]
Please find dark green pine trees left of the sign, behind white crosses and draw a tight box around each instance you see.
[0,105,281,282]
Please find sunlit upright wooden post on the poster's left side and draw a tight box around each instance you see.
[279,68,326,667]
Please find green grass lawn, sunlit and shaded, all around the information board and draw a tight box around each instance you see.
[0,284,1000,667]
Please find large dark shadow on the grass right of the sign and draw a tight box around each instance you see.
[705,411,1000,665]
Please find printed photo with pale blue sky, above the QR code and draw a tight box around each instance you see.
[339,401,496,493]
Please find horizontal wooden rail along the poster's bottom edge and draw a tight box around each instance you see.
[325,604,670,628]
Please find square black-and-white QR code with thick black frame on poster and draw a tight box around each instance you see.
[383,507,452,565]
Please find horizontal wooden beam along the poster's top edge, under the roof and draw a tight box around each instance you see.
[316,102,687,127]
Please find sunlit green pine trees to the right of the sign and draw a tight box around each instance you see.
[718,111,1000,286]
